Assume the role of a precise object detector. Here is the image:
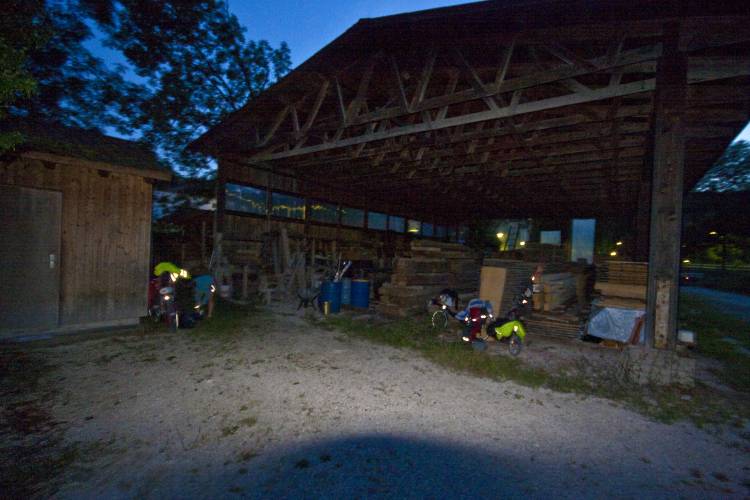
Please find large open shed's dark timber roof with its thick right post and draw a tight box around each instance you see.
[192,0,750,347]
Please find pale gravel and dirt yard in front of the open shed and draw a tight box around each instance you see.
[0,306,750,498]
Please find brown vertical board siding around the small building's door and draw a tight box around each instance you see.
[0,160,151,326]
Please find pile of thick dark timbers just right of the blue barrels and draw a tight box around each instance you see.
[377,240,479,316]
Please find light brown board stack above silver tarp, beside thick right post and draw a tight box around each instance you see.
[594,261,648,309]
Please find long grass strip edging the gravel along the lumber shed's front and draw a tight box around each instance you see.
[314,315,750,427]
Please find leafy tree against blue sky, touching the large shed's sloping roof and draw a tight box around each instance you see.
[82,0,291,176]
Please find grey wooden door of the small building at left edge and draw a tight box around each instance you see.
[0,186,62,335]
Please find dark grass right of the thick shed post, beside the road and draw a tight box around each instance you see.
[679,294,750,392]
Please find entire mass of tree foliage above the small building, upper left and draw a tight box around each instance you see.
[0,0,291,175]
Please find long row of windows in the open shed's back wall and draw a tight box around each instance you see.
[224,183,465,241]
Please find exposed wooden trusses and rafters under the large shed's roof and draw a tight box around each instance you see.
[213,18,750,217]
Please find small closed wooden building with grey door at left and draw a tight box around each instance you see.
[0,122,171,338]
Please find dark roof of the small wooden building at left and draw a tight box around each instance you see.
[0,119,172,180]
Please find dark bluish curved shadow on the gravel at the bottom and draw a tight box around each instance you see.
[106,432,728,499]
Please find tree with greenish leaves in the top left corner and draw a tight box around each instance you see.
[0,0,138,136]
